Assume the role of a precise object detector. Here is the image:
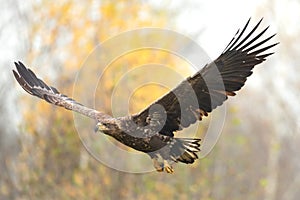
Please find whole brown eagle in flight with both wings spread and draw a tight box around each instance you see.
[13,19,278,173]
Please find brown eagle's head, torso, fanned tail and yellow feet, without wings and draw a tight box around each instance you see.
[96,117,200,172]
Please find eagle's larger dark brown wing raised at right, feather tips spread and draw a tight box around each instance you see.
[132,19,278,136]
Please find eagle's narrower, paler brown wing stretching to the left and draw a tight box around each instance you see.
[13,62,109,120]
